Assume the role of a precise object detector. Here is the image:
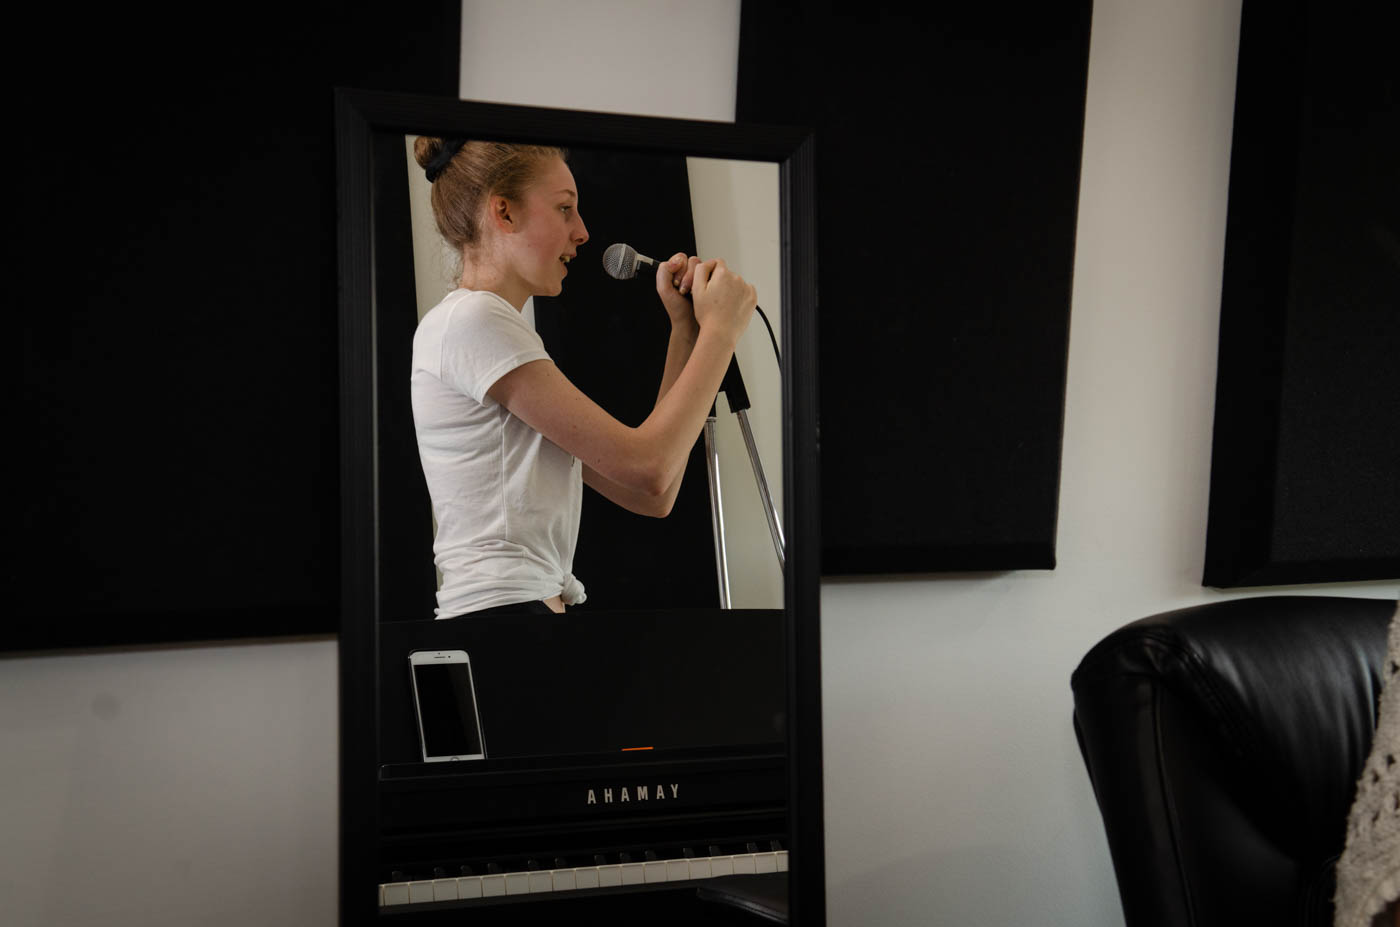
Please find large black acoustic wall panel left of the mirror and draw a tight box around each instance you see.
[12,3,461,650]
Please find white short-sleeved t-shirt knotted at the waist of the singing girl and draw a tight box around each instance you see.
[412,290,585,618]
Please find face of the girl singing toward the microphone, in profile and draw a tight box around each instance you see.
[507,158,588,295]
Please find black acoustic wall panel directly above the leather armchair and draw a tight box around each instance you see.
[1204,0,1400,587]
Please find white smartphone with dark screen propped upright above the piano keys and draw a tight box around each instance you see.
[409,650,486,763]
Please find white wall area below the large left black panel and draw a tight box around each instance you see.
[0,639,340,927]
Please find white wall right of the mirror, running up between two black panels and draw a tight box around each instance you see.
[822,0,1397,926]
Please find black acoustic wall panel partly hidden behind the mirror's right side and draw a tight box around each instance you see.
[738,1,1092,574]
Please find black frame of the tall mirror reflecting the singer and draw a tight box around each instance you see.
[335,88,826,927]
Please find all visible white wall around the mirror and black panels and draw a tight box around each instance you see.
[0,0,1397,927]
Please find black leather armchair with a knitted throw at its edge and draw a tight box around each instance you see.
[1071,595,1396,927]
